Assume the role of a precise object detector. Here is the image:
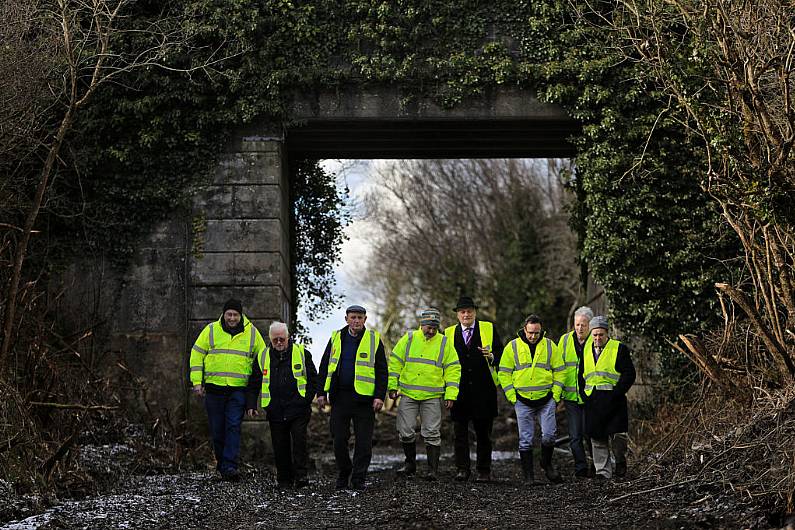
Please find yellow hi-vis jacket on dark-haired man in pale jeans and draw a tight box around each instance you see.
[498,337,563,403]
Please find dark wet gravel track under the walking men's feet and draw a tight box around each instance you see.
[0,451,770,530]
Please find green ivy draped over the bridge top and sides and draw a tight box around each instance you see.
[29,0,736,339]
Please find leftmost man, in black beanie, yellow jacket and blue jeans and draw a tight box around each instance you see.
[190,299,265,481]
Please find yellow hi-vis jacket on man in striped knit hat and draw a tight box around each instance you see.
[389,330,461,401]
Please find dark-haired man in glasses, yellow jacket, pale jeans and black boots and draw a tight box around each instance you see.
[498,315,563,484]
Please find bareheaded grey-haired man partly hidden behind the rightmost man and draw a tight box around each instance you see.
[555,306,593,478]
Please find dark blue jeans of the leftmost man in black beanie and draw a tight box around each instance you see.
[204,388,246,473]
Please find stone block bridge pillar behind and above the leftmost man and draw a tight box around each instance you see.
[187,138,291,354]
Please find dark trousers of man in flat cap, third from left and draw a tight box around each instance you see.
[329,391,375,484]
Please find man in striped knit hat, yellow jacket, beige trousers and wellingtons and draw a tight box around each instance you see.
[389,307,461,480]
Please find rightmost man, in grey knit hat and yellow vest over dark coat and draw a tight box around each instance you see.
[581,316,635,480]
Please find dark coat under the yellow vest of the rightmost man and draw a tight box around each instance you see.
[580,338,635,440]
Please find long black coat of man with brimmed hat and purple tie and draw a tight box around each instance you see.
[450,320,503,421]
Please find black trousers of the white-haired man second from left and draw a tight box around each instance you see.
[269,414,309,484]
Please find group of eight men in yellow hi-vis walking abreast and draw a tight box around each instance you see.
[190,296,635,490]
